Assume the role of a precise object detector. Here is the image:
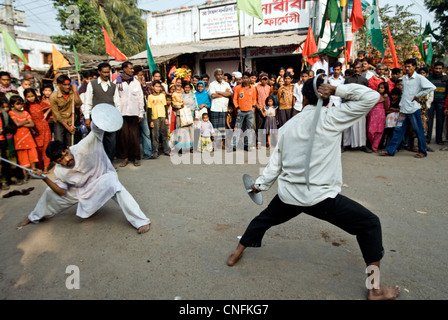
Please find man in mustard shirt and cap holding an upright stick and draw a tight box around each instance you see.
[50,75,82,146]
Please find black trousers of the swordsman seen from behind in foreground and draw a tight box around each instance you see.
[240,195,384,264]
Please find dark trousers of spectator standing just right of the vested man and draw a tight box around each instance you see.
[117,116,140,161]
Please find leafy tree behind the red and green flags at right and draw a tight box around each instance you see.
[357,4,423,64]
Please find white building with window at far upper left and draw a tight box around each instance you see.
[0,8,62,78]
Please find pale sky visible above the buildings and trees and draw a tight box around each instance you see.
[13,0,434,35]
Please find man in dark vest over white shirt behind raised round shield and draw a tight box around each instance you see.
[81,62,120,163]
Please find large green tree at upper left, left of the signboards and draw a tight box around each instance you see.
[52,0,146,56]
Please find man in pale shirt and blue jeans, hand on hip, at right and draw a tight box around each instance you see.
[379,59,436,158]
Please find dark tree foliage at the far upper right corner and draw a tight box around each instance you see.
[425,0,448,58]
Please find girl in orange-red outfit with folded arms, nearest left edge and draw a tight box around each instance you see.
[9,96,39,183]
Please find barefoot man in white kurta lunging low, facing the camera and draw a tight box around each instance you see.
[19,122,151,233]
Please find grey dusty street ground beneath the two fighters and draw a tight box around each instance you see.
[0,145,448,300]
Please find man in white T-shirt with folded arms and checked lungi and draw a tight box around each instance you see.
[209,68,232,143]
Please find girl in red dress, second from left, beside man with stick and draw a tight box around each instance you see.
[23,88,51,174]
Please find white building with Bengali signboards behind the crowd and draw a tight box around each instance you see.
[131,0,326,80]
